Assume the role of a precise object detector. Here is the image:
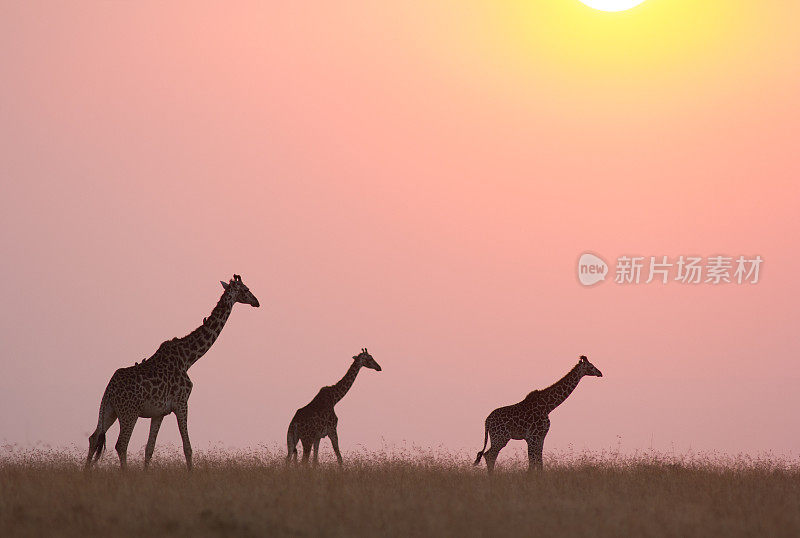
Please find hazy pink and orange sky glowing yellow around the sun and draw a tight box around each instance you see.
[0,0,800,458]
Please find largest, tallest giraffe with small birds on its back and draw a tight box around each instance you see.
[84,275,259,471]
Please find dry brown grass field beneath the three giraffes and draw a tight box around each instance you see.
[0,448,800,536]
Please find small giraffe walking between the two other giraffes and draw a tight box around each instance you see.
[286,348,381,466]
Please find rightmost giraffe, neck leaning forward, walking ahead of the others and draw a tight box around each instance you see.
[475,355,603,474]
